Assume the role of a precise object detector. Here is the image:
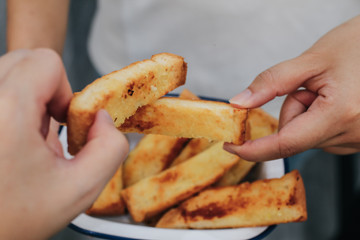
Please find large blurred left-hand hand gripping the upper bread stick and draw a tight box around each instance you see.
[0,49,128,239]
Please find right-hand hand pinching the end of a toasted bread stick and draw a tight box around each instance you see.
[224,17,360,161]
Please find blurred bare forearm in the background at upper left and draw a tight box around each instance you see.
[7,0,69,54]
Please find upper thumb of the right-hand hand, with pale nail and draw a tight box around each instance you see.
[229,53,322,108]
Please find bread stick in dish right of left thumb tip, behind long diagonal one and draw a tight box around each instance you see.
[123,134,188,187]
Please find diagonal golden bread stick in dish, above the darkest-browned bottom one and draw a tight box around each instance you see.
[121,142,239,222]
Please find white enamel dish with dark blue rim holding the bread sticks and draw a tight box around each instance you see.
[59,95,288,240]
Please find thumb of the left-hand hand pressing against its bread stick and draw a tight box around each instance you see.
[68,110,129,203]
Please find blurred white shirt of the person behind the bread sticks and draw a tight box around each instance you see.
[89,0,360,117]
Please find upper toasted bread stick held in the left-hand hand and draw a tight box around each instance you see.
[67,53,187,154]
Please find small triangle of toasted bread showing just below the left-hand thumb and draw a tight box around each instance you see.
[86,165,125,216]
